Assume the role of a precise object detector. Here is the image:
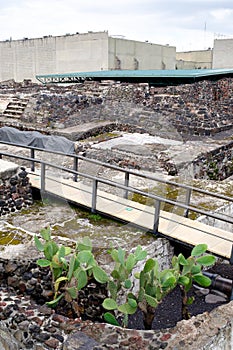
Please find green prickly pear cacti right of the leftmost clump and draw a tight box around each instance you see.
[103,244,216,329]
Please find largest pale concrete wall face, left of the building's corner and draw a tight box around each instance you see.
[0,32,108,81]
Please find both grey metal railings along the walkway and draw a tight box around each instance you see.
[0,141,233,233]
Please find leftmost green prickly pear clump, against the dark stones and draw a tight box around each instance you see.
[34,227,108,309]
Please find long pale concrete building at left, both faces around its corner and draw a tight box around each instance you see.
[0,31,176,82]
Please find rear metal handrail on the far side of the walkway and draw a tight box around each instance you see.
[0,141,233,203]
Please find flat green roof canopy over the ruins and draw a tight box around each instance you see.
[36,69,233,86]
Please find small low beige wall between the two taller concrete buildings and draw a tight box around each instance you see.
[176,49,212,69]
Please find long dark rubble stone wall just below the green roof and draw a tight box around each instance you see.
[0,78,233,139]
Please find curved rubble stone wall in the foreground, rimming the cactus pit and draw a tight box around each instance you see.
[0,252,233,350]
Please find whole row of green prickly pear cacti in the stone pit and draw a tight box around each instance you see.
[34,228,216,329]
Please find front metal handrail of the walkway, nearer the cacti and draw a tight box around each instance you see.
[0,152,233,233]
